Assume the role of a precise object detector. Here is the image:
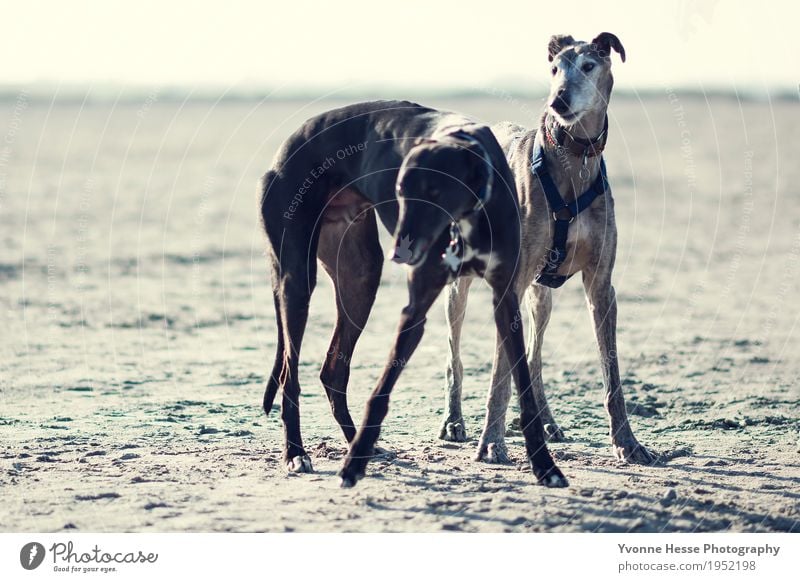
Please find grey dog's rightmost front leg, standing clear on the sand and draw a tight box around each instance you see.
[583,269,656,464]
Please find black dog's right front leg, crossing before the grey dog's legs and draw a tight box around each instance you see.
[494,287,568,487]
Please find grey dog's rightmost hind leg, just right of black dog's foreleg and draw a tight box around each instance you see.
[527,285,564,442]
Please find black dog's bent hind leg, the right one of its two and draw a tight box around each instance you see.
[317,209,383,443]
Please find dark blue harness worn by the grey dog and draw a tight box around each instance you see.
[531,118,608,289]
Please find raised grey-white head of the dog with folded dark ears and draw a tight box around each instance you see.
[547,32,625,127]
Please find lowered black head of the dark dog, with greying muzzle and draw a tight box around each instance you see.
[392,138,490,266]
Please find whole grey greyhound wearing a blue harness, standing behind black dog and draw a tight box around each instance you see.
[440,32,655,463]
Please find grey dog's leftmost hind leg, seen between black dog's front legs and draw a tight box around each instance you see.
[439,277,472,442]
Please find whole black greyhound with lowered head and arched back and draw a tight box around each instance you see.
[261,101,567,487]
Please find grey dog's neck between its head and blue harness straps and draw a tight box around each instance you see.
[537,109,608,202]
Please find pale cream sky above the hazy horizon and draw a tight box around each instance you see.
[0,0,800,91]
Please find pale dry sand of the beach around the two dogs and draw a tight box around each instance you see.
[0,93,800,532]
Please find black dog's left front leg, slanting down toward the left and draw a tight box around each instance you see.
[339,266,446,487]
